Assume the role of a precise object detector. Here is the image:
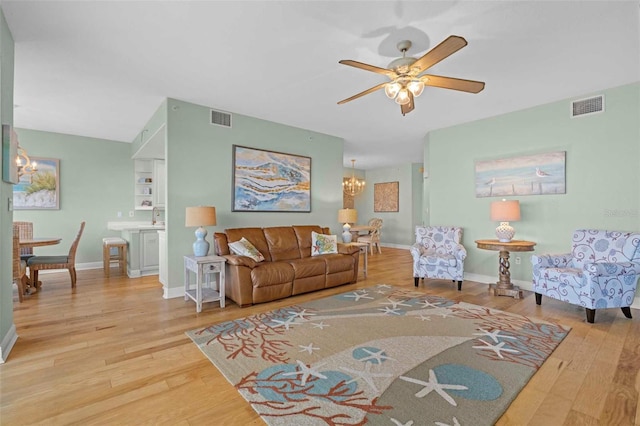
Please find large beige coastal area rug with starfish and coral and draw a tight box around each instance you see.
[187,284,569,426]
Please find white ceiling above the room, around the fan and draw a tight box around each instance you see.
[0,0,640,169]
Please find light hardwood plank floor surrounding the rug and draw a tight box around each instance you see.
[0,248,640,426]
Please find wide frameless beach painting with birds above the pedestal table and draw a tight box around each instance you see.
[475,151,566,198]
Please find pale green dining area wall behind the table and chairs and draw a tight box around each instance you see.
[14,129,138,263]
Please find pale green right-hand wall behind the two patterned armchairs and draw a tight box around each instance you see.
[424,83,640,281]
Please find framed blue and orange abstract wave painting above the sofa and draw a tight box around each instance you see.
[231,145,311,213]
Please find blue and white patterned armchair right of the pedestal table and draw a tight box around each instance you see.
[531,229,640,323]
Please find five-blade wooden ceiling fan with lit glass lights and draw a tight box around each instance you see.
[338,35,484,115]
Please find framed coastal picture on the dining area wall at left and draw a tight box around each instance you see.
[13,157,60,210]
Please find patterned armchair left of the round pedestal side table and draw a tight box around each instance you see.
[411,226,467,291]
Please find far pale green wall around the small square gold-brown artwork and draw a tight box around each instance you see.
[358,164,415,246]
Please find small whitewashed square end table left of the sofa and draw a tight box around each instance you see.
[184,255,227,313]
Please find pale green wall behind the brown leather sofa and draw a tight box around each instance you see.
[166,99,344,287]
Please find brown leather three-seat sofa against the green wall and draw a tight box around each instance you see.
[214,225,360,306]
